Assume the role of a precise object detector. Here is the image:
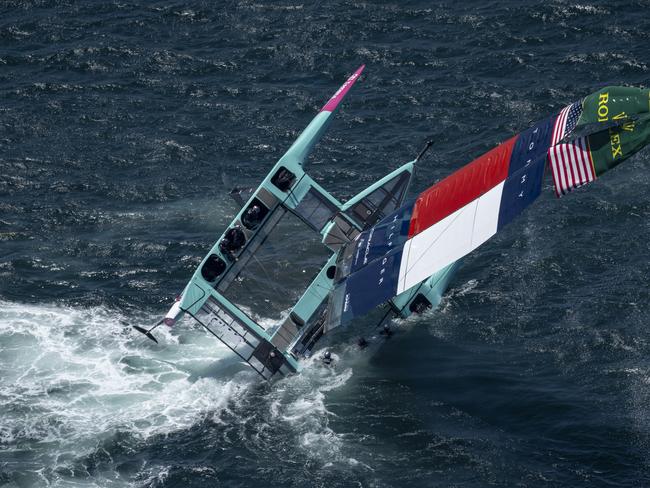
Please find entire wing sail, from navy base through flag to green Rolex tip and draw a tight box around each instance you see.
[328,87,650,328]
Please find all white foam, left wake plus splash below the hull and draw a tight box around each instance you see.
[0,301,355,487]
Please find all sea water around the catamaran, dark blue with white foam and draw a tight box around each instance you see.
[0,0,650,488]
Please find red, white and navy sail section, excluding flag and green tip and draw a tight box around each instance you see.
[330,113,557,325]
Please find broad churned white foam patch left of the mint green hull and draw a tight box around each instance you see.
[0,302,256,479]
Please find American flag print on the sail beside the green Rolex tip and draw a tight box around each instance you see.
[548,102,596,197]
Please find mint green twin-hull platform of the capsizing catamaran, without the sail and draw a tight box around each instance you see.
[163,70,455,379]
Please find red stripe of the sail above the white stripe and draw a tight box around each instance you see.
[409,136,519,239]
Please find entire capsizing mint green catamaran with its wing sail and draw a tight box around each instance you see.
[135,66,650,380]
